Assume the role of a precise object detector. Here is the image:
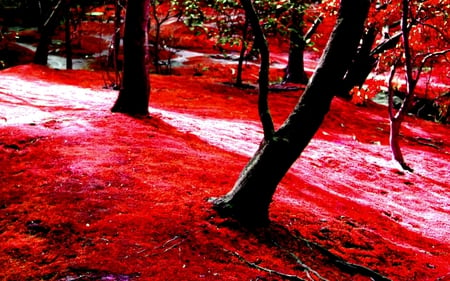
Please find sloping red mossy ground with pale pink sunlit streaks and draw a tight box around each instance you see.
[0,65,450,280]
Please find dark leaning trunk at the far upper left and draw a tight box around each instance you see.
[33,0,67,65]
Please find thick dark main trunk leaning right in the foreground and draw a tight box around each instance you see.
[212,0,370,224]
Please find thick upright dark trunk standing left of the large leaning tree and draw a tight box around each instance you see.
[112,0,150,115]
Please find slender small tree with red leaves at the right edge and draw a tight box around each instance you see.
[388,0,450,172]
